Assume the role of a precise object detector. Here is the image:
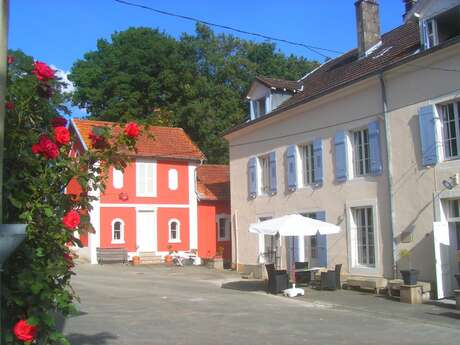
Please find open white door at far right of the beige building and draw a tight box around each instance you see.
[433,222,452,299]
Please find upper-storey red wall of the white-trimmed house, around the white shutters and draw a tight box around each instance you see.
[101,160,189,204]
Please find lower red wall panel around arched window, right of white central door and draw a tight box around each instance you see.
[157,208,190,251]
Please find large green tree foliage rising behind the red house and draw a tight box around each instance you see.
[69,24,317,163]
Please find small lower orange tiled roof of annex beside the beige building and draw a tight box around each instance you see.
[197,164,230,200]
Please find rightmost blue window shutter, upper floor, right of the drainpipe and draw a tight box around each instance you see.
[418,105,438,166]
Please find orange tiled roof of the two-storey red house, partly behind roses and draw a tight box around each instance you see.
[72,119,205,160]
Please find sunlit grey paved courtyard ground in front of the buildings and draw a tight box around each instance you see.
[64,264,460,345]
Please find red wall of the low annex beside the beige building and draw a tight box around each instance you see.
[198,202,217,258]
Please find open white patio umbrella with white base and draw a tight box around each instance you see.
[249,214,340,297]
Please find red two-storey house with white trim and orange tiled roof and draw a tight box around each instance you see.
[67,119,231,263]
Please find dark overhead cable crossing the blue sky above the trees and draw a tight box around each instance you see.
[114,0,343,59]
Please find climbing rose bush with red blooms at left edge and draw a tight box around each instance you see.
[2,51,140,345]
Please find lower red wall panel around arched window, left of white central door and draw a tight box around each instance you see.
[101,207,137,252]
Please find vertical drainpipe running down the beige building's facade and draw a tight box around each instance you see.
[379,72,397,279]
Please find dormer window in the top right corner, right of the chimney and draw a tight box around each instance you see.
[422,6,460,49]
